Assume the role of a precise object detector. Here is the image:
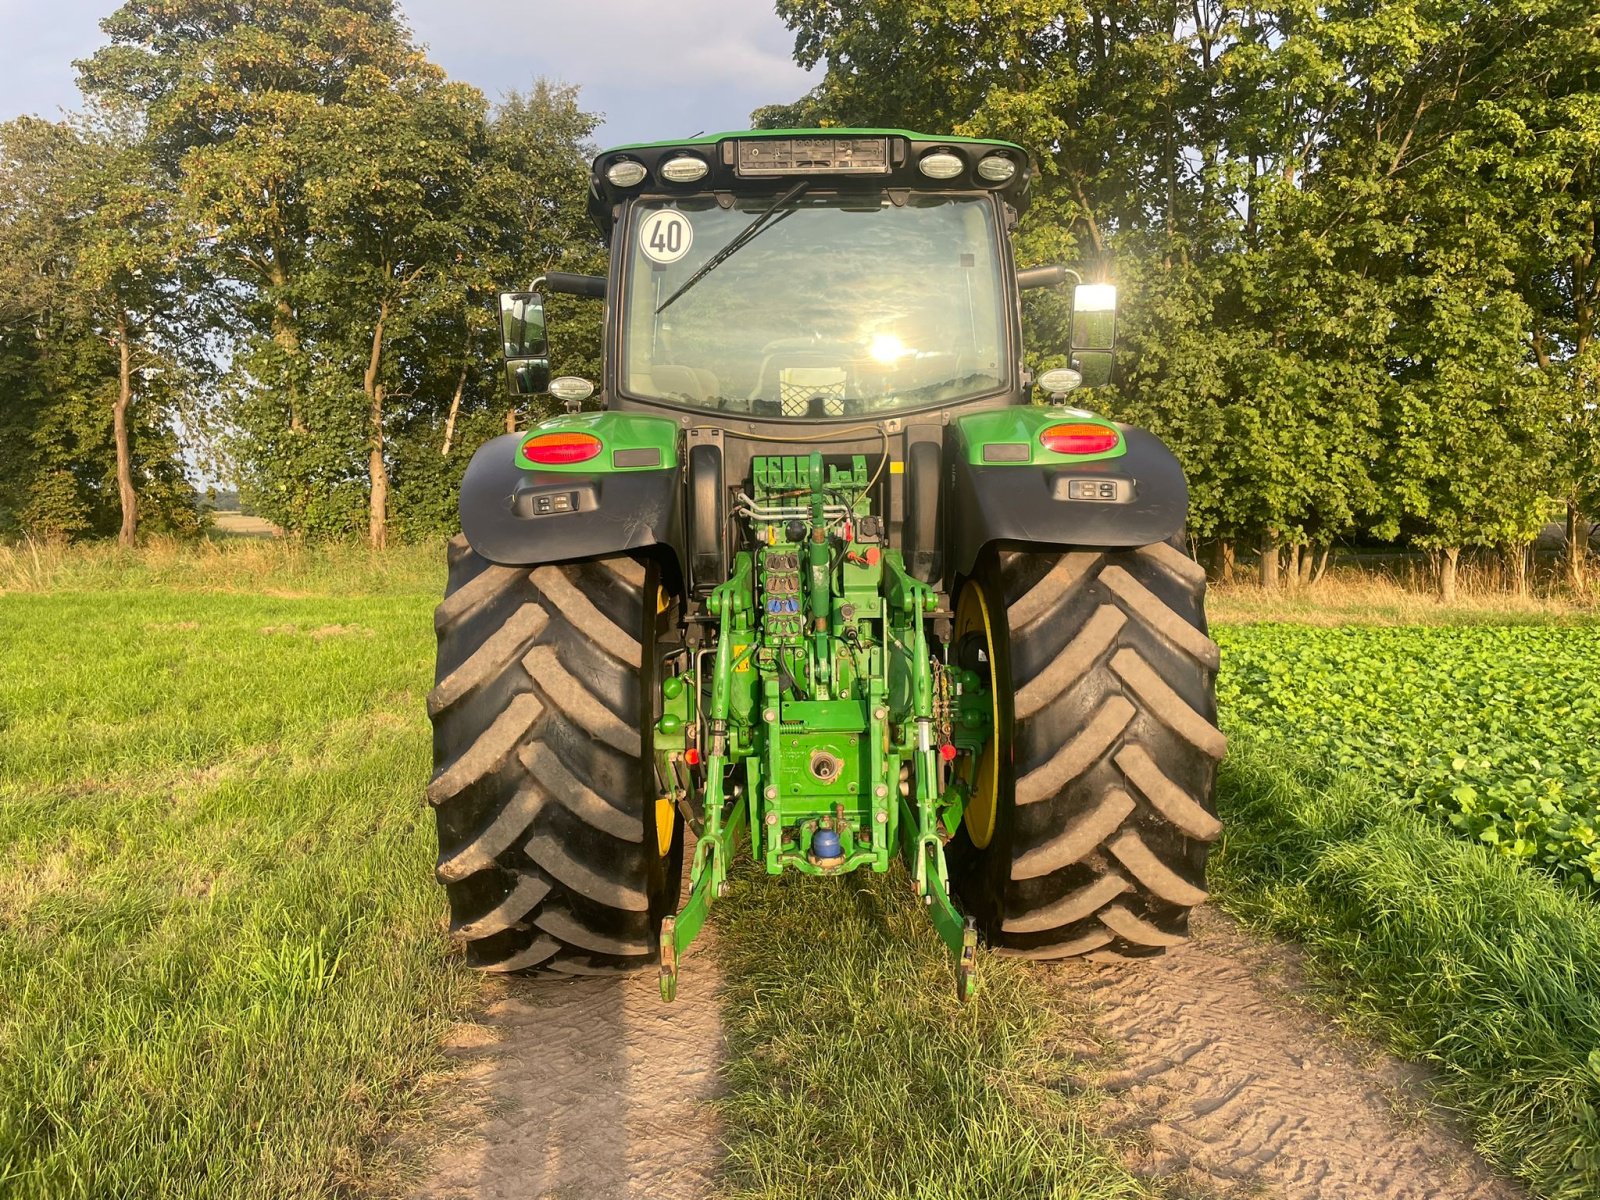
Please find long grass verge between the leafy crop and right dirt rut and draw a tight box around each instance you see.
[1211,733,1600,1200]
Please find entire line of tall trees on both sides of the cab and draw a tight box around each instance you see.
[0,0,1600,601]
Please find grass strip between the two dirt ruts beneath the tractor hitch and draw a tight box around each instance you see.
[717,869,1152,1200]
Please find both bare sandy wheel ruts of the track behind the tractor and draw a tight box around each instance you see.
[413,909,1523,1200]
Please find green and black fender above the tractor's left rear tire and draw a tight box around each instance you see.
[461,413,680,566]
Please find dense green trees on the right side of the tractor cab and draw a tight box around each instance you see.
[757,0,1600,590]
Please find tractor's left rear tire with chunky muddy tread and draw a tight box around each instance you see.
[427,536,683,976]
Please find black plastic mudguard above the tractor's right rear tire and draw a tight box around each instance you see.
[946,426,1189,574]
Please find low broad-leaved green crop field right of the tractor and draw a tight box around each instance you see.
[1218,624,1600,885]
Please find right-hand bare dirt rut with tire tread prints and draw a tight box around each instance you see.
[1037,909,1526,1200]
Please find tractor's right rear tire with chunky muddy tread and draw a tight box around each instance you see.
[952,542,1226,958]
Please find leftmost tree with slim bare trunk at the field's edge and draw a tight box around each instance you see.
[0,112,198,544]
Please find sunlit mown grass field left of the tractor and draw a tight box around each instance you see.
[0,546,478,1200]
